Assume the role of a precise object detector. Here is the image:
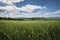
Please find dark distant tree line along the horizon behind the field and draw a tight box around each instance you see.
[0,17,60,20]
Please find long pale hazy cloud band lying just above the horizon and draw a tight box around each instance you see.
[0,10,59,18]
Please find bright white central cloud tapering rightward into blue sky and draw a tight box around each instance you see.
[20,4,46,12]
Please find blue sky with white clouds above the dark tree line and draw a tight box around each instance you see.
[0,0,60,18]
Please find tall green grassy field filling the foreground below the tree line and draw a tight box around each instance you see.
[0,20,60,40]
